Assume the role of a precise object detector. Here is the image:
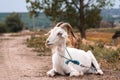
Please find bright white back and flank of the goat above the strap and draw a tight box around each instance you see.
[65,47,92,67]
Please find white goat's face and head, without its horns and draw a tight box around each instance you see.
[46,27,67,47]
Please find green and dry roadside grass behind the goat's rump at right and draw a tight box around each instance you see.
[80,43,120,70]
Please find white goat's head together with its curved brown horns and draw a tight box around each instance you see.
[46,22,76,46]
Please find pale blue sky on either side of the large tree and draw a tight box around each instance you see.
[0,0,120,12]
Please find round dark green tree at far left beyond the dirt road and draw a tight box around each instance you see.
[5,13,24,32]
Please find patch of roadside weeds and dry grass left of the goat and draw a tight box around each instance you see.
[26,30,51,56]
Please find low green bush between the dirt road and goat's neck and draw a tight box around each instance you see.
[26,36,50,56]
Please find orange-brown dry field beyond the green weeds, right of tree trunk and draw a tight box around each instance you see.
[87,28,120,46]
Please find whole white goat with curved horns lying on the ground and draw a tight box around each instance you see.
[46,23,103,77]
